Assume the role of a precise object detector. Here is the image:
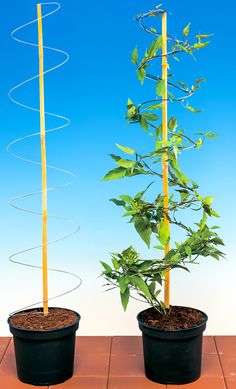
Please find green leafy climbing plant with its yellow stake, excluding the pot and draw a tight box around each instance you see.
[101,6,224,315]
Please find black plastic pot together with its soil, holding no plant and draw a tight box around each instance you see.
[8,308,80,385]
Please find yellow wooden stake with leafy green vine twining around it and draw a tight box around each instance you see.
[162,12,170,308]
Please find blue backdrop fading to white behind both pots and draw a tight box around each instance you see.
[0,0,236,333]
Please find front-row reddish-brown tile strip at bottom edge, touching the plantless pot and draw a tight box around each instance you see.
[51,377,107,389]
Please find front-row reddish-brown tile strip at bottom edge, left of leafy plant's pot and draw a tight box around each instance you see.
[107,377,165,389]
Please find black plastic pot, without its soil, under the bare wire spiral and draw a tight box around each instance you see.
[8,308,80,385]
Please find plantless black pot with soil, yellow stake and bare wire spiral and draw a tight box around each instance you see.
[8,3,81,385]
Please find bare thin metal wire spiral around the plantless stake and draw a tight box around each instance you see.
[7,2,82,315]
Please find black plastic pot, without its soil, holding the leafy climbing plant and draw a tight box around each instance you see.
[137,309,208,385]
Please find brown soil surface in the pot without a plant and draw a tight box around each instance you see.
[10,308,77,331]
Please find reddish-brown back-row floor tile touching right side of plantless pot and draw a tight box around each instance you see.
[74,336,111,377]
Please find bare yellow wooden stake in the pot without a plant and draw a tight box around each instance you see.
[37,4,48,315]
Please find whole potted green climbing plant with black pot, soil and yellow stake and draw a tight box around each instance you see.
[101,6,224,384]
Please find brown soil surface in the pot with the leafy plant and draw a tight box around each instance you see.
[141,306,205,330]
